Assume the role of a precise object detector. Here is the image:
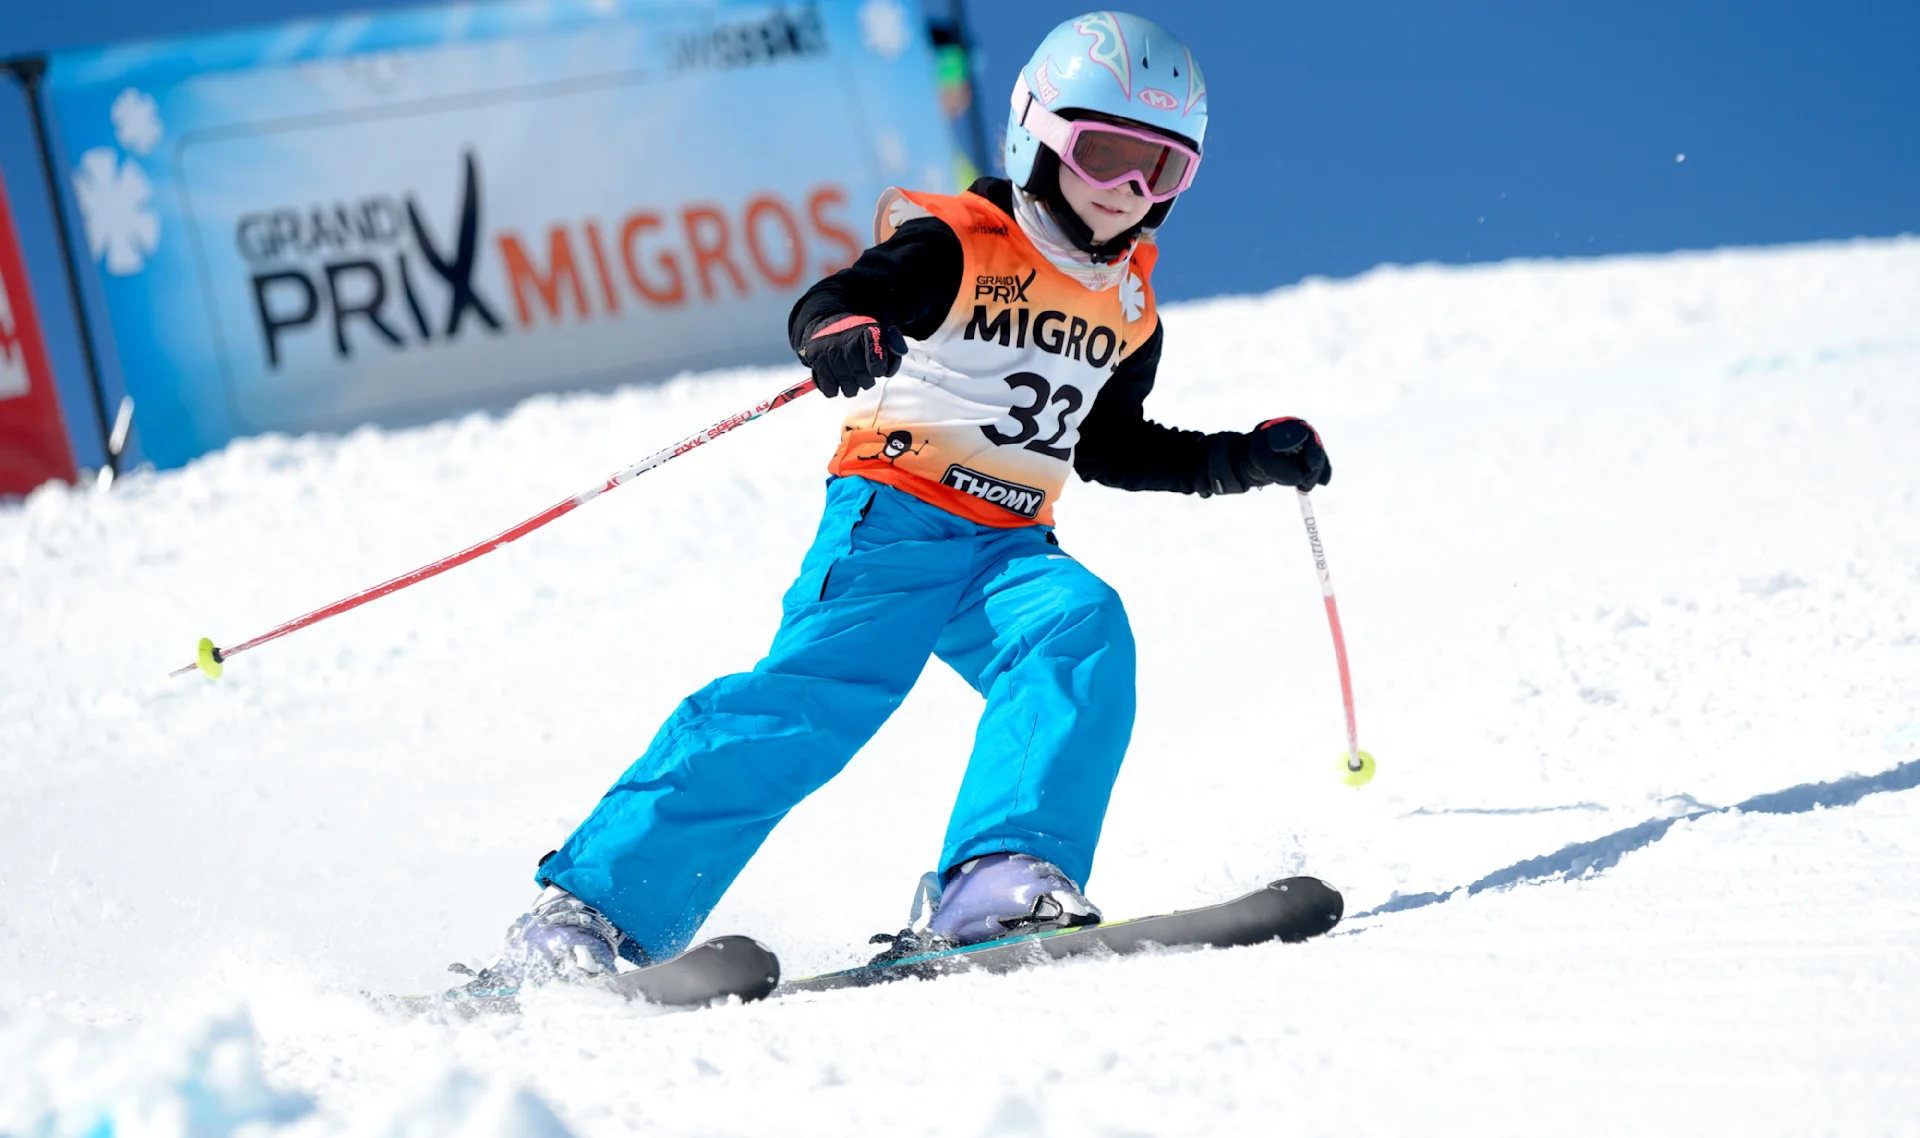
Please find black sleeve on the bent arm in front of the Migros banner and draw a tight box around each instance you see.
[787,217,966,351]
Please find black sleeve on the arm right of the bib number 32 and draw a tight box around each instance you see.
[1073,326,1248,497]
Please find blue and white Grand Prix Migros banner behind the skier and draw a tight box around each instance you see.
[48,0,954,466]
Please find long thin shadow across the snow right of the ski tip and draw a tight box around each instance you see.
[1350,760,1920,919]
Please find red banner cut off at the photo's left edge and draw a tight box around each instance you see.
[0,165,77,495]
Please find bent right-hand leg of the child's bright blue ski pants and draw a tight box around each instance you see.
[935,530,1135,887]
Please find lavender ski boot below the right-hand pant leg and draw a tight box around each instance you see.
[872,854,1100,963]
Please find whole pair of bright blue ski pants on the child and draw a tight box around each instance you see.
[536,476,1135,960]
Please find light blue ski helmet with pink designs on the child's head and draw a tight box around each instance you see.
[1004,12,1206,186]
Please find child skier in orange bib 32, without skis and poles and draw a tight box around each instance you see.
[490,12,1331,981]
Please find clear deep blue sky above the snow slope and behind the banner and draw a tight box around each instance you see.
[0,0,1920,460]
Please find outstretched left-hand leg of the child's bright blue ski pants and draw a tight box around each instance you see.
[538,478,970,960]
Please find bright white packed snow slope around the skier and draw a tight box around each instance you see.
[0,240,1920,1138]
